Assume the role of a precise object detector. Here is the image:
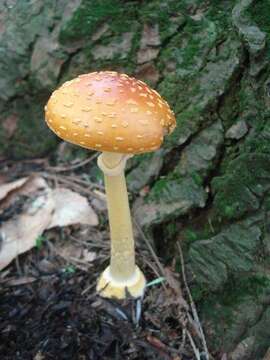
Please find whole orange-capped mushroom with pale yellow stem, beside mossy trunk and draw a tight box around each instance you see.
[45,71,175,299]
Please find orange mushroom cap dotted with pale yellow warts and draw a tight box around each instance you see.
[45,71,175,154]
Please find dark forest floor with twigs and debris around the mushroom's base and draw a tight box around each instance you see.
[0,150,212,360]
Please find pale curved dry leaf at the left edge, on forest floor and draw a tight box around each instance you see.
[0,177,54,270]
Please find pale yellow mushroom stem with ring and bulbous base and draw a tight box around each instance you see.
[98,153,145,299]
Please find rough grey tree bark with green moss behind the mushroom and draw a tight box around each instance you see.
[0,0,270,360]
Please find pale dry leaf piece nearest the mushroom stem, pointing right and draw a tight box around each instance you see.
[48,188,98,229]
